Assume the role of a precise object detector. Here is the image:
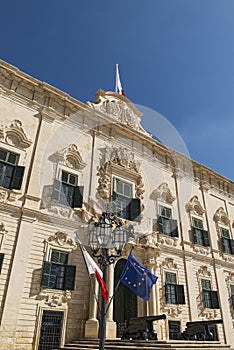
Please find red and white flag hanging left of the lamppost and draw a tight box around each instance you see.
[80,243,109,301]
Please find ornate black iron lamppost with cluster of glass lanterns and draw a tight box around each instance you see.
[89,212,134,350]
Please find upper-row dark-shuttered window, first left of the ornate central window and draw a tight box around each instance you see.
[53,170,83,208]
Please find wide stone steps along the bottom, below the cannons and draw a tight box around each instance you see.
[55,339,230,350]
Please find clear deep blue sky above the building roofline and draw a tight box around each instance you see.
[0,0,234,180]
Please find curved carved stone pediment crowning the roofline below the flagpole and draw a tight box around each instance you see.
[87,90,151,136]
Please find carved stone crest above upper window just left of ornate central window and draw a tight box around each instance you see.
[51,144,86,170]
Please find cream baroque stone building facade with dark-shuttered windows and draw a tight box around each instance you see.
[0,61,234,350]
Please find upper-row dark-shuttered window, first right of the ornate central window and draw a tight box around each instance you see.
[158,207,179,237]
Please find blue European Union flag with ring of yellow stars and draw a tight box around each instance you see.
[120,253,158,300]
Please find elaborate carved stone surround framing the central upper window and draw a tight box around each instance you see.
[97,147,145,199]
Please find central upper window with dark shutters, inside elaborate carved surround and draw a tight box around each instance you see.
[112,178,141,221]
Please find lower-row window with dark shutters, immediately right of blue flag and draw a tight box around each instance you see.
[165,272,185,304]
